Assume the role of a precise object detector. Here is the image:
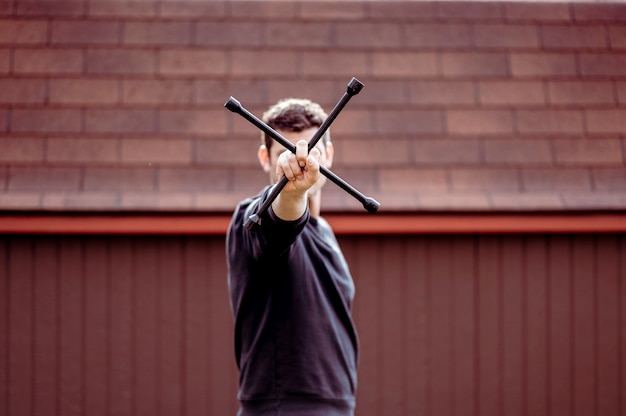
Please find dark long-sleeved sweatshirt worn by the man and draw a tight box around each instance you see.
[226,187,358,416]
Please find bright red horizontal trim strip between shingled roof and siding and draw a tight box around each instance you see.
[0,213,626,235]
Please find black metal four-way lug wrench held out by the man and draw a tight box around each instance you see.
[224,78,380,229]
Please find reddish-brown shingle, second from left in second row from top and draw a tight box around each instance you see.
[51,21,121,45]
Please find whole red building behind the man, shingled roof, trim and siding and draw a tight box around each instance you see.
[0,0,626,416]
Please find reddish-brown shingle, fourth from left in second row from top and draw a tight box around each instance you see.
[194,21,267,47]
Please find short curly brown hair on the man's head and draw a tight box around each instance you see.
[261,98,330,156]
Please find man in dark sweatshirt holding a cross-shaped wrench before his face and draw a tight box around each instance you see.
[226,99,358,416]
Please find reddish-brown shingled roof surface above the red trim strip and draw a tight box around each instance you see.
[0,0,626,211]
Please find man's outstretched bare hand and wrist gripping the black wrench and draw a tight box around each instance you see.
[272,140,321,221]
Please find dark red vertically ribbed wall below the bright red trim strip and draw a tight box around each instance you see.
[0,234,626,416]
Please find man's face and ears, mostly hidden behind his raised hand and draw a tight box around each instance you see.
[259,127,334,194]
